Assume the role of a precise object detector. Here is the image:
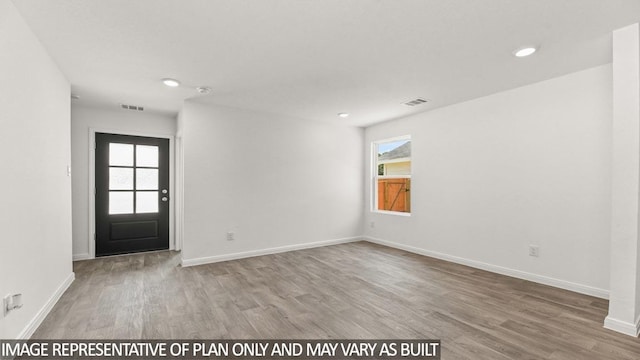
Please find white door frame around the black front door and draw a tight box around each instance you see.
[88,127,182,259]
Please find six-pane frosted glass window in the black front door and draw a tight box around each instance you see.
[109,143,159,215]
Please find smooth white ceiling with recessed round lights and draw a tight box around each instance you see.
[13,0,640,126]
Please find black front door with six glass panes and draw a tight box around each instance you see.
[96,133,169,256]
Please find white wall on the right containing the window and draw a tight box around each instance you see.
[364,65,612,297]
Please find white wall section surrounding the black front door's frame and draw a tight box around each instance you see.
[71,104,176,259]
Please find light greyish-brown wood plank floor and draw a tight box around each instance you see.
[33,242,640,359]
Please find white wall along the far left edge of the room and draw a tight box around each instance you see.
[0,0,73,339]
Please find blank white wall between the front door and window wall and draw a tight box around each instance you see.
[179,101,364,265]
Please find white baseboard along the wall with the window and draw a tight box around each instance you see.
[363,236,609,299]
